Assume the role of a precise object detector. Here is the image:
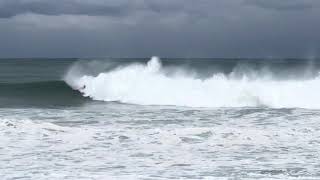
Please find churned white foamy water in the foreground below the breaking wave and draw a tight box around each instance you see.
[0,105,320,179]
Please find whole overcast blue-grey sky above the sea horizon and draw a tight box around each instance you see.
[0,0,320,58]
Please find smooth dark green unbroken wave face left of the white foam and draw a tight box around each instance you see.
[0,80,88,107]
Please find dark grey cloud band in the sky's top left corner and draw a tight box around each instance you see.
[0,0,132,18]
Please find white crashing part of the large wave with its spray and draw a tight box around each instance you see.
[65,57,320,109]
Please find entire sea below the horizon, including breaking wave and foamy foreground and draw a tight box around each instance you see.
[0,57,320,180]
